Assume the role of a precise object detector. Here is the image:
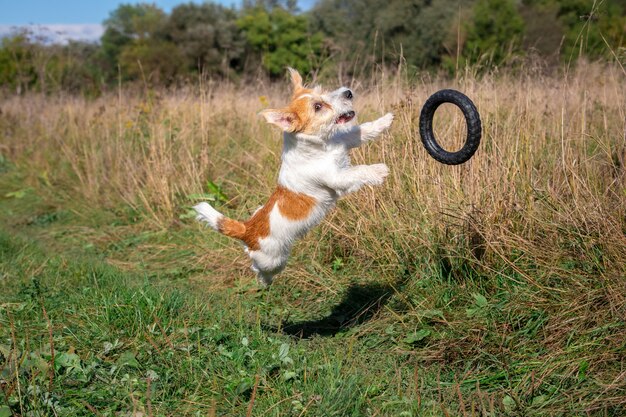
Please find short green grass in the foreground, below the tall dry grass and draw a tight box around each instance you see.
[0,157,626,416]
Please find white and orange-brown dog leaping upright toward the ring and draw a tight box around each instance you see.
[194,68,393,287]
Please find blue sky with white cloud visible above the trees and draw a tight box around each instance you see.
[0,0,314,43]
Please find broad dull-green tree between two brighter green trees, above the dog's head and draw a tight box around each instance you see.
[310,0,472,72]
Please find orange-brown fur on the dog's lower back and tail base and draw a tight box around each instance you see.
[218,186,317,250]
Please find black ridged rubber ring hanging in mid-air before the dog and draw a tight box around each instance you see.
[420,90,482,165]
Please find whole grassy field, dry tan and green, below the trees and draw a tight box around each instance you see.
[0,63,626,416]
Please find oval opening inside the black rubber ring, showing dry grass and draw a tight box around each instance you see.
[433,103,467,152]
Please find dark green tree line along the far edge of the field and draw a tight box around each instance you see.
[0,0,626,93]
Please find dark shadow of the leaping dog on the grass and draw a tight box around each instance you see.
[264,280,405,339]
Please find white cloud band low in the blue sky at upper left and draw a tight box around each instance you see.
[0,24,104,44]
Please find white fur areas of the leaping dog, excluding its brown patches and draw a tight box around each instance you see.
[194,74,393,286]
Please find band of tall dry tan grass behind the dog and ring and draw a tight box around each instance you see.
[0,64,626,263]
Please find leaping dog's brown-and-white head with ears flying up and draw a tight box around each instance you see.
[261,68,356,136]
